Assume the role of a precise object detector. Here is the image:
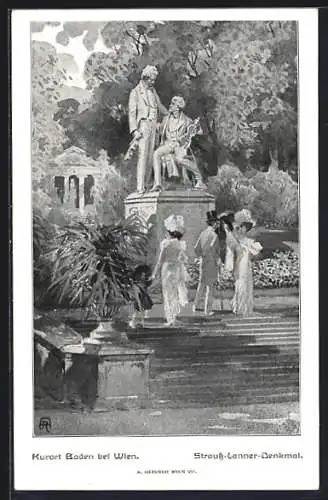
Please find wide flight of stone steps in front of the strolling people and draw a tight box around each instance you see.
[129,313,300,408]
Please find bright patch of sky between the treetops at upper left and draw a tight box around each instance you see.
[31,24,111,88]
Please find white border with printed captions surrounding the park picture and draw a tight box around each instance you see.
[12,9,319,490]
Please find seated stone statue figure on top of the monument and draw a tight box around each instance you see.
[152,96,206,191]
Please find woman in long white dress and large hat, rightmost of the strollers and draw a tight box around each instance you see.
[227,210,262,317]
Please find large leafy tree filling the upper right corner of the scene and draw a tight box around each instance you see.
[204,22,297,173]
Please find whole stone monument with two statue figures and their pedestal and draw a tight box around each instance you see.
[125,70,215,263]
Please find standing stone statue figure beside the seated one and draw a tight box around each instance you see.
[129,66,167,192]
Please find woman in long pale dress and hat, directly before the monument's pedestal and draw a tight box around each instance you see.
[152,215,188,326]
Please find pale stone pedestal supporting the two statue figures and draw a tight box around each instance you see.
[125,190,215,261]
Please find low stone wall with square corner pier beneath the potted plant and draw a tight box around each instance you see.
[34,314,153,411]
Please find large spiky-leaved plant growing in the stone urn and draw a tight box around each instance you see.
[49,216,147,319]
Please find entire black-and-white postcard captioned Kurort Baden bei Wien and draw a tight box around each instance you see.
[12,9,319,491]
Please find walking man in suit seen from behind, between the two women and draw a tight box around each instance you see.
[192,211,220,316]
